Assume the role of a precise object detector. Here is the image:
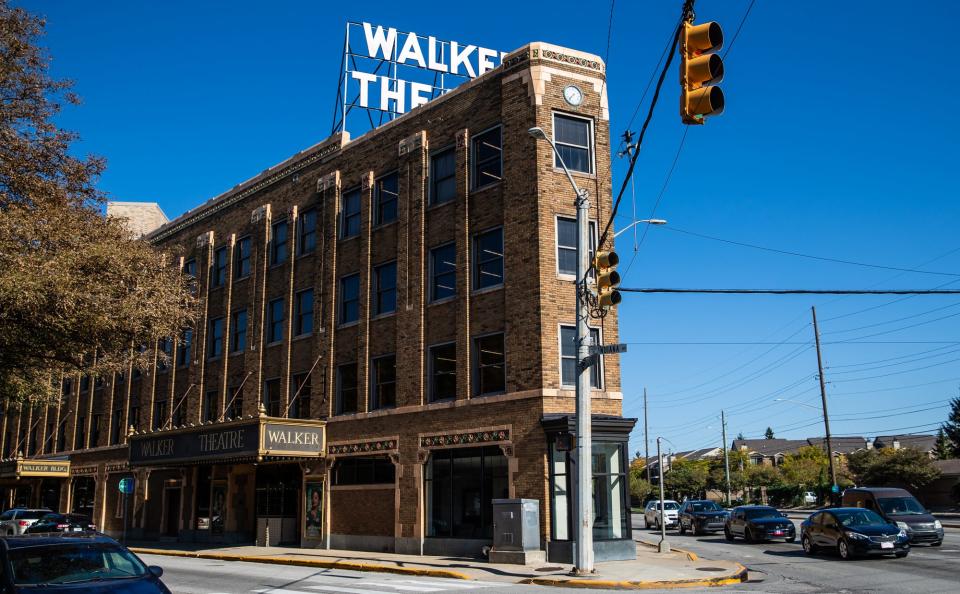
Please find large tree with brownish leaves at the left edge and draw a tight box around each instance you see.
[0,0,194,405]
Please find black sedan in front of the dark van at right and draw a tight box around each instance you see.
[800,507,910,559]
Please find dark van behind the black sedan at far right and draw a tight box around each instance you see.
[843,487,943,547]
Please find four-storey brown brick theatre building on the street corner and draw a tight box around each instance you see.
[0,43,635,561]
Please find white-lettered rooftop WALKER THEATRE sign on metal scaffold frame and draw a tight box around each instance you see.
[333,22,506,132]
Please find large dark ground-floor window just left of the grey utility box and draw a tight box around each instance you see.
[424,446,510,539]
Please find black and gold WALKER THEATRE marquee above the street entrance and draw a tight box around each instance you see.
[129,416,326,466]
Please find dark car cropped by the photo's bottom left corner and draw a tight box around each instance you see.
[0,534,170,594]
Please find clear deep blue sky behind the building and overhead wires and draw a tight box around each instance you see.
[24,0,960,450]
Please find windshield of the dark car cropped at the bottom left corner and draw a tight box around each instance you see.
[7,543,147,586]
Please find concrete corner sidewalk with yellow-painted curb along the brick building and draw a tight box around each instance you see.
[130,542,747,589]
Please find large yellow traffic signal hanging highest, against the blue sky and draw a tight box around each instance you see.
[680,21,724,124]
